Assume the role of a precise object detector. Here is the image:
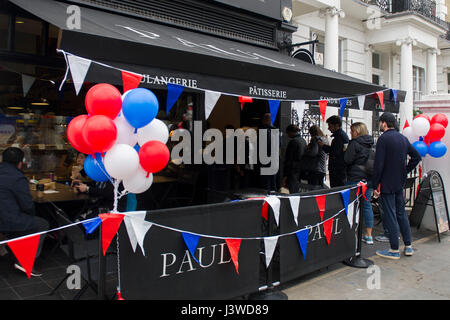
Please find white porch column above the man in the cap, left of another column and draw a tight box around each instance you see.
[396,38,416,128]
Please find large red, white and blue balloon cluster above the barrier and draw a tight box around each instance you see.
[67,83,170,193]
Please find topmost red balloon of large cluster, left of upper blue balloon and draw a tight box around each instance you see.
[85,83,122,120]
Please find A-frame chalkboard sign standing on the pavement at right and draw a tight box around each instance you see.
[410,170,450,241]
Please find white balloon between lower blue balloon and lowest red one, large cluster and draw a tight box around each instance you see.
[103,144,139,180]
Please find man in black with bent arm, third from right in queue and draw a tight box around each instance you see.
[318,116,349,188]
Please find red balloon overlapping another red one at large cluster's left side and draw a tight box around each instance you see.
[83,115,118,154]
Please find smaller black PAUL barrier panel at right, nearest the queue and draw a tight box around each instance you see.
[279,187,359,283]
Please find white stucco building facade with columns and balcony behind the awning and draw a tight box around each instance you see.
[292,0,450,130]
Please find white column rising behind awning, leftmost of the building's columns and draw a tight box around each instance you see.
[319,7,345,71]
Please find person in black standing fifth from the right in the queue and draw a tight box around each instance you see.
[282,124,306,193]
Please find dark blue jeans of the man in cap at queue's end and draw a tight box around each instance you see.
[380,190,411,250]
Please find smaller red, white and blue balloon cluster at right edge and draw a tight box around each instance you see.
[403,113,448,158]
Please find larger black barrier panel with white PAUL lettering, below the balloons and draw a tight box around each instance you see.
[119,200,263,299]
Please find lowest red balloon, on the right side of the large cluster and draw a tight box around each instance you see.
[139,140,170,173]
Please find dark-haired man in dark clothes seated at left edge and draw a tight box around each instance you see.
[0,147,49,277]
